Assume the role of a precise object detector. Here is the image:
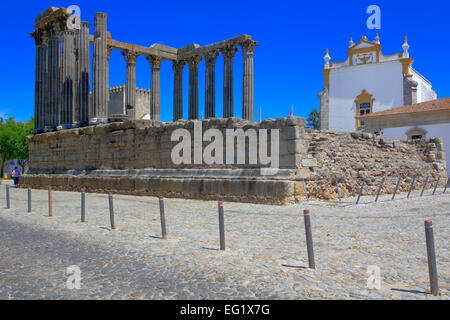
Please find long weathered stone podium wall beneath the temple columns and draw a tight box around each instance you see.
[21,117,446,204]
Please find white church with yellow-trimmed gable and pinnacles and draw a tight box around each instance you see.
[319,34,436,131]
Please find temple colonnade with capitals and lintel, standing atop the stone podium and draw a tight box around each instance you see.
[31,7,258,133]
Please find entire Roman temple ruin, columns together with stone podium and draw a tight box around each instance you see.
[20,7,445,204]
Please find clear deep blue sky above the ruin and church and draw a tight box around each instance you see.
[0,0,450,121]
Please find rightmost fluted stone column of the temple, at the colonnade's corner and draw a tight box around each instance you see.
[241,40,258,121]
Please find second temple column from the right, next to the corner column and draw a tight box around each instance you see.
[221,45,238,118]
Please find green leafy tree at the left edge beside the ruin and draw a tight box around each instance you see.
[0,117,34,177]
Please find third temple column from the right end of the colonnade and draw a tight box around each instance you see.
[205,50,219,119]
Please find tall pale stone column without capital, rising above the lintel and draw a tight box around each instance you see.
[89,12,109,124]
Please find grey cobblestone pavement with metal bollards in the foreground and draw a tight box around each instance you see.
[0,186,450,299]
